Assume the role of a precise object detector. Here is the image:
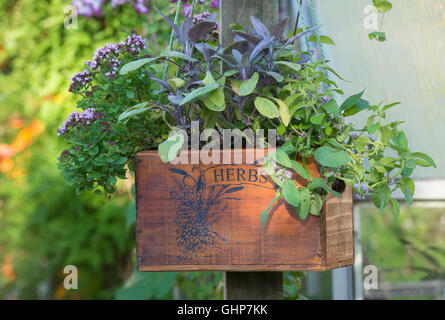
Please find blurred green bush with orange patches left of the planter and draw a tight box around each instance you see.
[0,0,299,299]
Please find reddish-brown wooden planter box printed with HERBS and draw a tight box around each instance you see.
[135,150,354,271]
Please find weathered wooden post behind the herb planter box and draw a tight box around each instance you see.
[220,0,283,300]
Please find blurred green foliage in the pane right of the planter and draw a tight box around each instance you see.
[360,205,445,299]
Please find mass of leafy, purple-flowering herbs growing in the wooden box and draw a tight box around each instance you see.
[60,12,435,223]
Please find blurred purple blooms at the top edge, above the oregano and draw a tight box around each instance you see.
[71,0,150,18]
